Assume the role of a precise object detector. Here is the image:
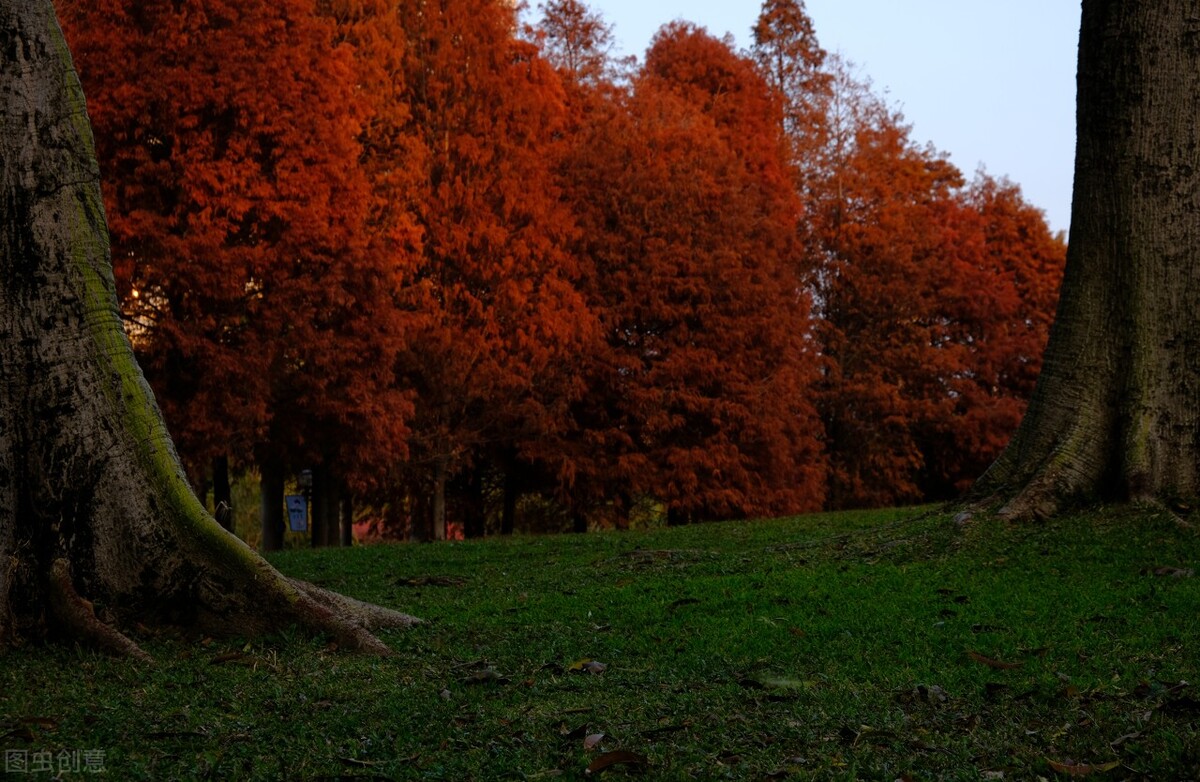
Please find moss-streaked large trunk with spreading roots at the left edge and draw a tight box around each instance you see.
[0,0,413,656]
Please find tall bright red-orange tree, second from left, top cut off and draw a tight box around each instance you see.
[400,0,592,537]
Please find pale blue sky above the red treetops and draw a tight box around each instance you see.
[561,0,1080,231]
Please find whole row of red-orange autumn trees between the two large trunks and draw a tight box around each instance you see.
[55,0,1066,548]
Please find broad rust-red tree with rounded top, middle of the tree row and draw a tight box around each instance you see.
[558,24,823,521]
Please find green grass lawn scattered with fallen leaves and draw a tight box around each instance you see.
[0,509,1200,782]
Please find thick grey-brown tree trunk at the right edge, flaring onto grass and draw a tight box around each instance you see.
[974,0,1200,517]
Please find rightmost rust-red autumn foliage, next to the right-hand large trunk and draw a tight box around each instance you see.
[805,64,1062,507]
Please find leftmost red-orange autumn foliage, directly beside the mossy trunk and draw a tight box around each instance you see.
[62,0,407,547]
